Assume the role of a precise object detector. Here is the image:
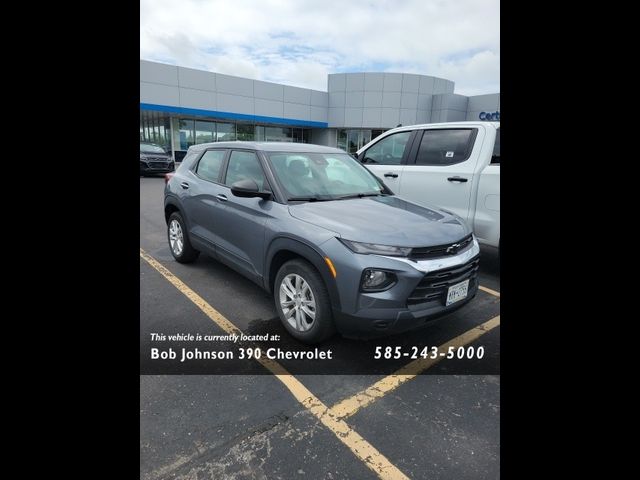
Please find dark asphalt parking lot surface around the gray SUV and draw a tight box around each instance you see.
[140,177,500,480]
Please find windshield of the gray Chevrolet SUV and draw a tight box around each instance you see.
[267,152,383,200]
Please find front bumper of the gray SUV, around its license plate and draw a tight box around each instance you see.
[323,238,480,338]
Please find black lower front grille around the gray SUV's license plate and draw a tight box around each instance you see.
[407,256,480,306]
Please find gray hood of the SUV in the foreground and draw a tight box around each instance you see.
[289,196,471,247]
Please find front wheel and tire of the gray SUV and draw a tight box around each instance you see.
[273,260,336,344]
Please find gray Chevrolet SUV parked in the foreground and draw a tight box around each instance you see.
[164,142,480,343]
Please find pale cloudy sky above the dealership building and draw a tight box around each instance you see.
[140,0,500,95]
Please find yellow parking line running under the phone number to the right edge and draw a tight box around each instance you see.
[331,315,500,419]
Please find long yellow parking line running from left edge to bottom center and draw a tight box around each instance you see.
[140,248,408,480]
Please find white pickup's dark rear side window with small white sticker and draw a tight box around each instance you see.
[416,129,475,166]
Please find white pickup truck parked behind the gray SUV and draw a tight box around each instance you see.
[357,122,500,248]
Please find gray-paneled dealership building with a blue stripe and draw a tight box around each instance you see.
[140,60,500,161]
